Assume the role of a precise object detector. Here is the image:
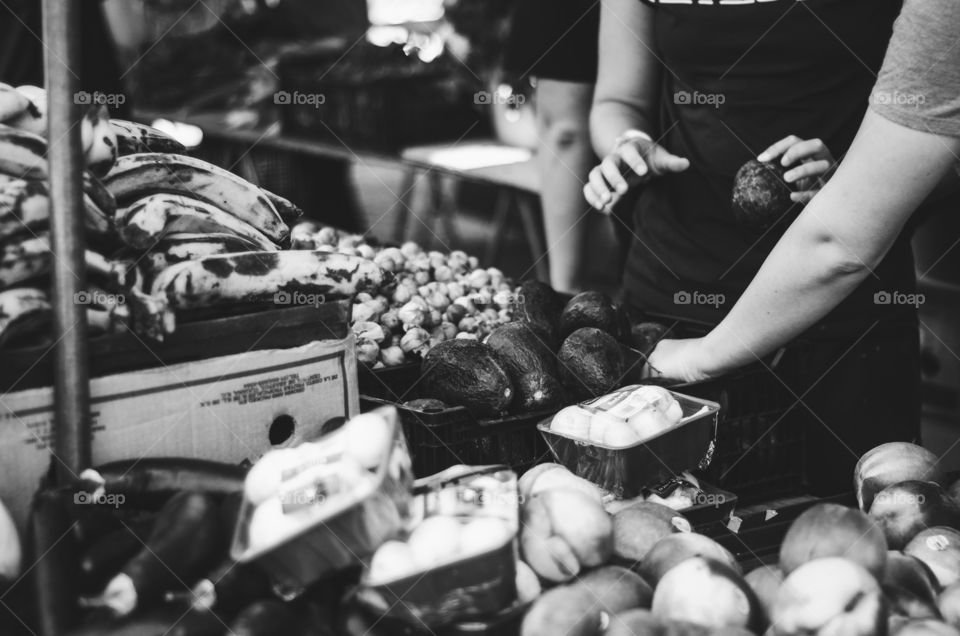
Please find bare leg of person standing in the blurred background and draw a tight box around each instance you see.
[537,79,596,293]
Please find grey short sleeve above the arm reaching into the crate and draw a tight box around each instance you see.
[870,0,960,137]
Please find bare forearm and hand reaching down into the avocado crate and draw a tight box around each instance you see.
[650,111,960,380]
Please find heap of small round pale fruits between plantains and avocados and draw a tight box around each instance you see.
[290,221,514,369]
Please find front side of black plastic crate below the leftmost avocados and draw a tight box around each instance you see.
[360,386,555,477]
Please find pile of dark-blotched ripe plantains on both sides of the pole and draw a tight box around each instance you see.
[0,85,390,346]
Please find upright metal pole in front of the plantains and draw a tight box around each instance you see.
[43,0,90,483]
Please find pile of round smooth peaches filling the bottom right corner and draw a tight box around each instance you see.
[510,443,960,636]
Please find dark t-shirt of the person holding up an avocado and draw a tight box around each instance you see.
[624,0,914,323]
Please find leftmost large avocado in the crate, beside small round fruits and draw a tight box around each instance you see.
[420,340,514,417]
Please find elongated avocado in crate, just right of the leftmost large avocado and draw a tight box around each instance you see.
[486,322,564,411]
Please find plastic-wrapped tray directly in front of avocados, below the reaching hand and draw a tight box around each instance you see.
[538,385,720,499]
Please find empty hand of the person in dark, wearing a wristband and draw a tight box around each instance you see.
[583,135,690,212]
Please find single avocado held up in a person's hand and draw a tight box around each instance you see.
[733,159,793,229]
